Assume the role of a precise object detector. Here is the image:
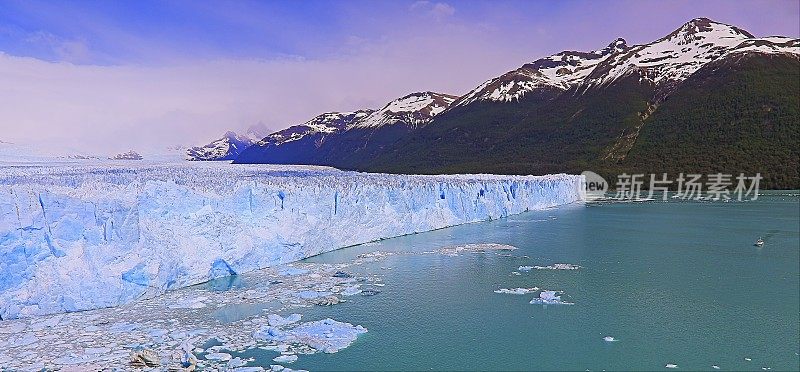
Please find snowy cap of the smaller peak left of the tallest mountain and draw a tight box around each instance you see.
[350,92,458,128]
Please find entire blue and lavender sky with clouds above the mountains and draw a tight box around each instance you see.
[0,0,800,155]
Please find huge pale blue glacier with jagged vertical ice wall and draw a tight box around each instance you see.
[0,162,584,319]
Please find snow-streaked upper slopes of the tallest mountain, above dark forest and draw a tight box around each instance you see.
[453,18,800,106]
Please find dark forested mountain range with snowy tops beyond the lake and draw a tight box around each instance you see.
[206,18,800,188]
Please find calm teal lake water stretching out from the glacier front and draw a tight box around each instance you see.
[241,192,800,370]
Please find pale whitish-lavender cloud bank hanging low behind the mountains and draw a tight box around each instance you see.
[0,26,528,155]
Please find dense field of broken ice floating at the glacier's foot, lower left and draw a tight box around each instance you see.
[0,262,380,371]
